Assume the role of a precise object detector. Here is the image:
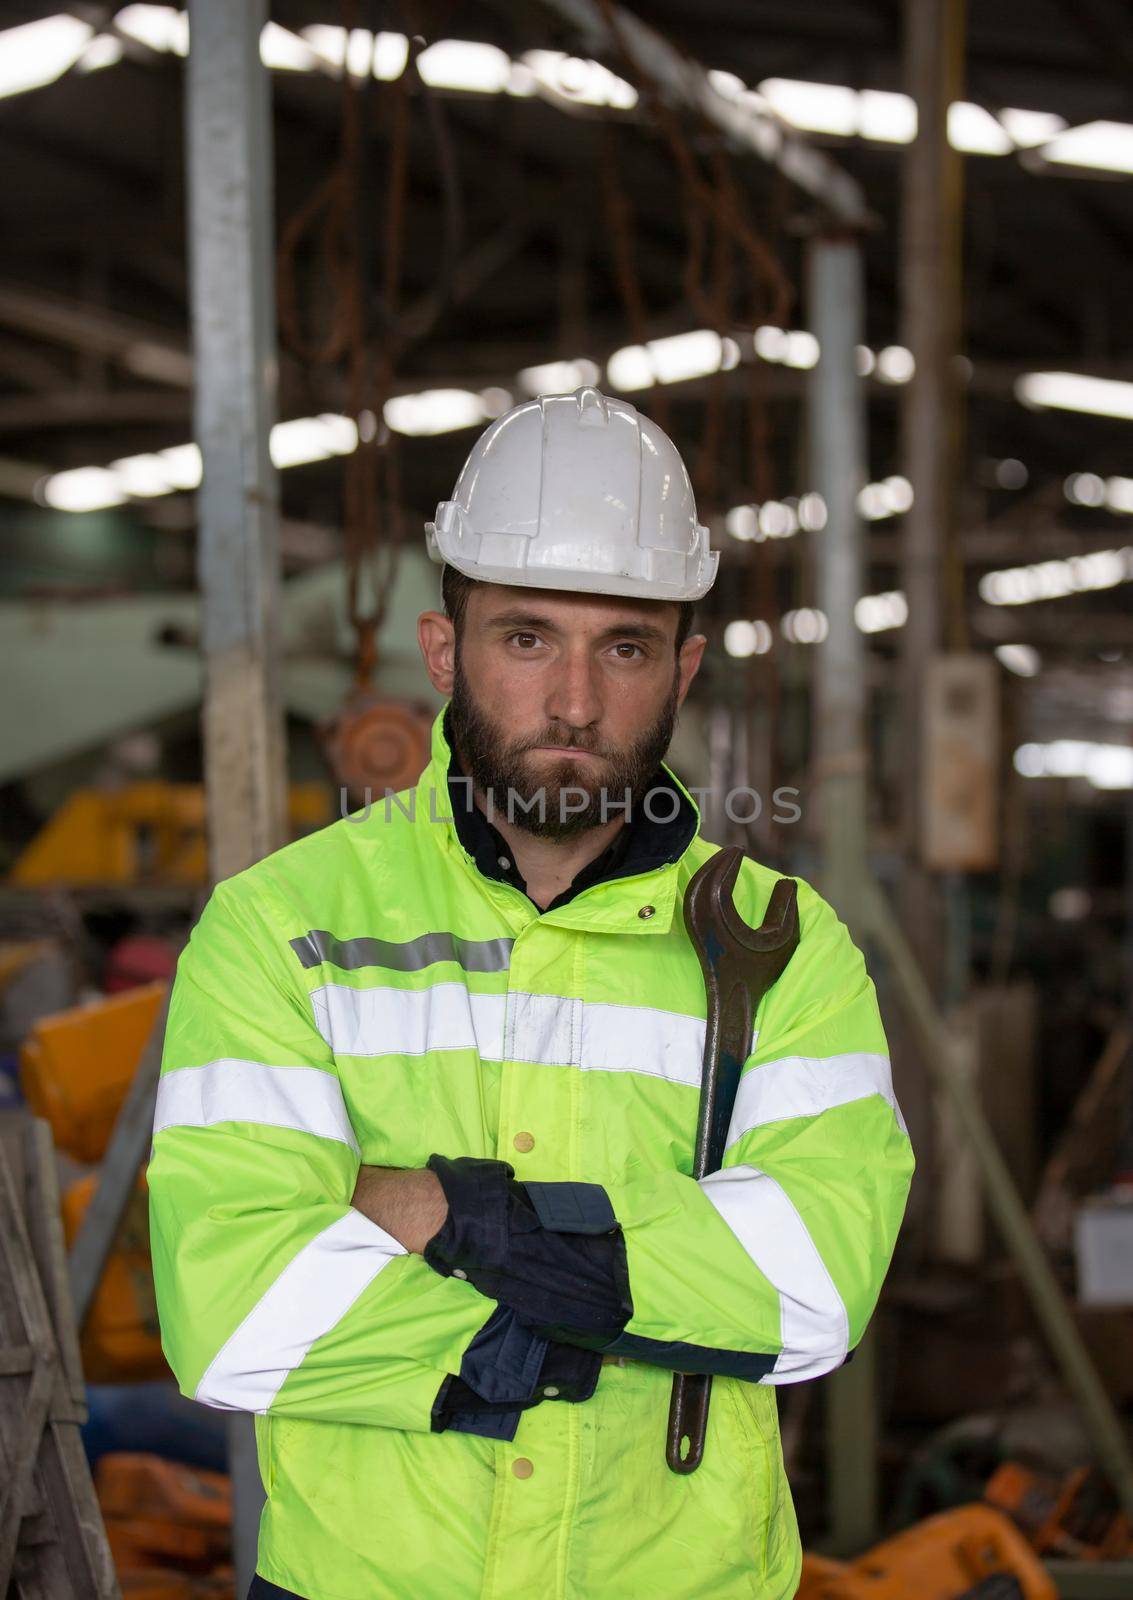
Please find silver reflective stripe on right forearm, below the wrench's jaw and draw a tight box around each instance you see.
[699,1166,850,1384]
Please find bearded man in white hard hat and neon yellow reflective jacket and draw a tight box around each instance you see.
[149,389,912,1600]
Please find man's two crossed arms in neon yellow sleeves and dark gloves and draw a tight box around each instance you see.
[149,880,912,1437]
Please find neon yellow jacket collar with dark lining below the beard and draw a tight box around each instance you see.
[416,704,701,933]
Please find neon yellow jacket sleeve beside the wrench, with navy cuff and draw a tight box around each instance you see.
[430,883,912,1384]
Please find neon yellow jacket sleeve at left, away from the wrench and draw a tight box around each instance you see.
[147,875,544,1432]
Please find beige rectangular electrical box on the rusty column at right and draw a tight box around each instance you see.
[920,654,1000,872]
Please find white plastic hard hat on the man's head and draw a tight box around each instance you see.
[426,387,720,600]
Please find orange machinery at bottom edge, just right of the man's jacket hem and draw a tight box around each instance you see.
[797,1506,1058,1600]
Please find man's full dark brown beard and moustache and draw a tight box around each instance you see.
[448,645,680,838]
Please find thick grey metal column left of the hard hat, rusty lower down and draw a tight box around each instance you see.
[186,0,285,1595]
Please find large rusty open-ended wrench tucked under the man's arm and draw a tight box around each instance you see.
[666,845,799,1472]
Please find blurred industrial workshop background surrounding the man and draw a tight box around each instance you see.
[0,0,1133,1600]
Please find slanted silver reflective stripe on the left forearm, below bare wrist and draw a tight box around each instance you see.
[197,1210,405,1411]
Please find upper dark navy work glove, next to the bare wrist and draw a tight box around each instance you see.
[424,1154,634,1350]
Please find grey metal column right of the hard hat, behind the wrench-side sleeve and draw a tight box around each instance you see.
[808,232,877,1555]
